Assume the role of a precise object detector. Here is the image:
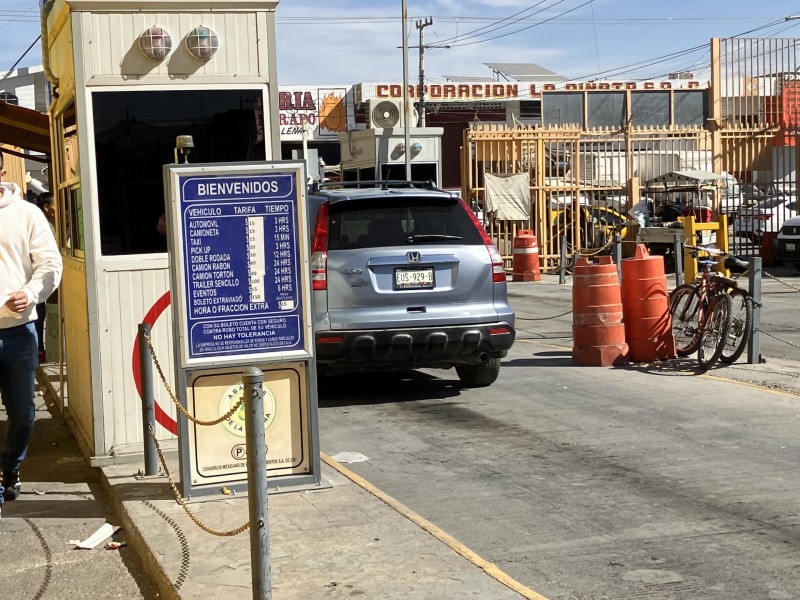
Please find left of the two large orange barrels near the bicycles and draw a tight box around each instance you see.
[572,256,628,367]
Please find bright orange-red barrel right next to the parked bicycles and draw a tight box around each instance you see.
[621,244,676,362]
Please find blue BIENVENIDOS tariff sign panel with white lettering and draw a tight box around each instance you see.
[178,172,304,360]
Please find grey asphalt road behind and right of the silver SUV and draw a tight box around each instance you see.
[320,277,800,600]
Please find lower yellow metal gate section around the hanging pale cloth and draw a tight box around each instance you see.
[462,124,711,269]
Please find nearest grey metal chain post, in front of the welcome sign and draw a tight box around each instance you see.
[242,367,272,600]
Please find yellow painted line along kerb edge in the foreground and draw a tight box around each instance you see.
[320,452,548,600]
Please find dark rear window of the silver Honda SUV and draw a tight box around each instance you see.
[328,197,484,250]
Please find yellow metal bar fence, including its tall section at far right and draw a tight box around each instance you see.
[461,38,800,270]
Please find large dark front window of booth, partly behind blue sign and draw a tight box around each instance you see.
[92,89,266,256]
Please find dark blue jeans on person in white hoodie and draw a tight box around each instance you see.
[0,323,39,503]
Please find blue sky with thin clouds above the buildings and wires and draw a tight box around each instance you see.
[0,0,800,85]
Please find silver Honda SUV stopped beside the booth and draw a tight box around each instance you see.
[309,181,515,387]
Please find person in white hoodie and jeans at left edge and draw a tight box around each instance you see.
[0,152,62,505]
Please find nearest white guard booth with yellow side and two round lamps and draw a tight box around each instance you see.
[42,0,280,464]
